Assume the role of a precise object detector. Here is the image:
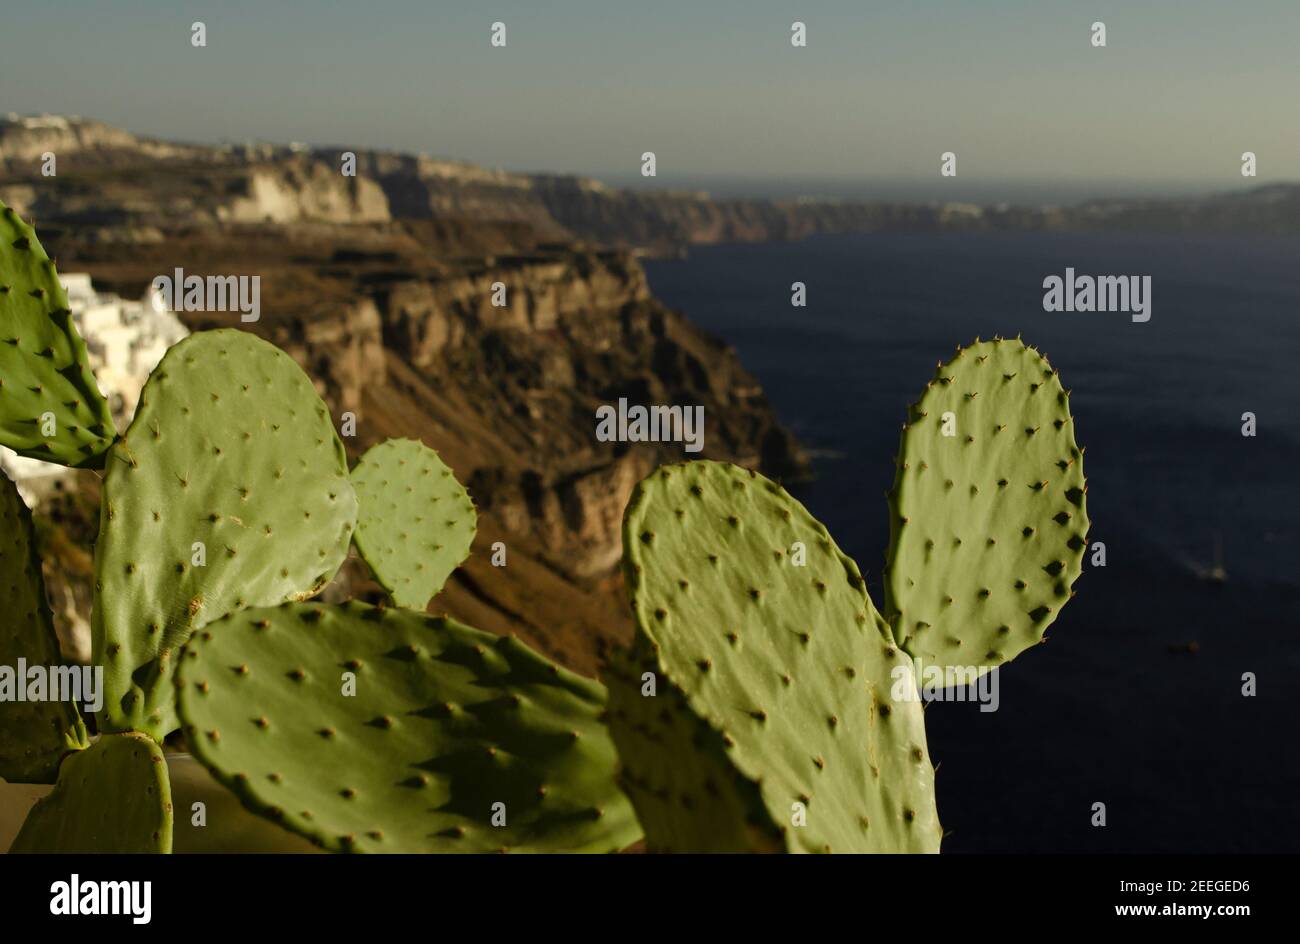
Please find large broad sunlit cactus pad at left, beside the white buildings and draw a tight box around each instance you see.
[91,329,356,737]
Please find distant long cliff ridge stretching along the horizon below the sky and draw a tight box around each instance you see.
[0,116,1300,252]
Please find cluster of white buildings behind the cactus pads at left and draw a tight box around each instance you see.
[0,273,189,505]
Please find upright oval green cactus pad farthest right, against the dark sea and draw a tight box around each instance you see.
[885,339,1088,684]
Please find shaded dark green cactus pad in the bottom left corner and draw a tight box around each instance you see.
[9,735,172,853]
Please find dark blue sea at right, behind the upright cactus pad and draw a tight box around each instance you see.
[646,233,1300,852]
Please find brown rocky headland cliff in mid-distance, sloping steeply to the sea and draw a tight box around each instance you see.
[167,240,806,587]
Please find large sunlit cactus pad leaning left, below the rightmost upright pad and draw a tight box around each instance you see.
[611,462,941,852]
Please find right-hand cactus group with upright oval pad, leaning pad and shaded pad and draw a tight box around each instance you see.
[606,339,1088,852]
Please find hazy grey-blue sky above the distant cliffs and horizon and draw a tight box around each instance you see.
[0,0,1300,200]
